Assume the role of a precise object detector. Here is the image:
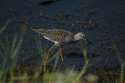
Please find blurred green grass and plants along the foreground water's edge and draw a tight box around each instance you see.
[0,18,125,83]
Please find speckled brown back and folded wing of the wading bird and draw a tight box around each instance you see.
[33,28,74,42]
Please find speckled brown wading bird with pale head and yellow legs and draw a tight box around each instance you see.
[33,28,88,62]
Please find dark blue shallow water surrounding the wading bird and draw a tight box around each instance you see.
[0,0,125,69]
